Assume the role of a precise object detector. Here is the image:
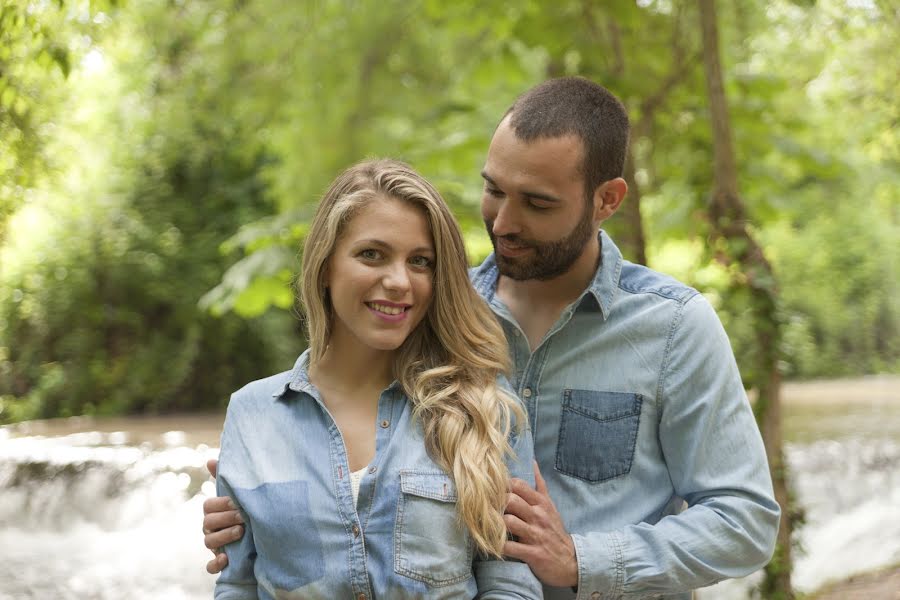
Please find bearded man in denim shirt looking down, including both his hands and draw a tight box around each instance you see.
[204,78,780,600]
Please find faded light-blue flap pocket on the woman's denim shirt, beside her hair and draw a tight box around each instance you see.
[394,471,475,586]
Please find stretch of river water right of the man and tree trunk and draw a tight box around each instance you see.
[696,376,900,600]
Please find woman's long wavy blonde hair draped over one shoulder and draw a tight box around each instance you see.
[299,159,525,557]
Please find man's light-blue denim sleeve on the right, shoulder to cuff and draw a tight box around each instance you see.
[572,294,781,600]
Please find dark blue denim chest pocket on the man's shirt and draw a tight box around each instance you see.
[556,390,643,483]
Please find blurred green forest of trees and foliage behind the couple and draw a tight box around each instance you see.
[0,0,900,598]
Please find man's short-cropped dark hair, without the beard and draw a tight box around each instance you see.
[504,77,629,199]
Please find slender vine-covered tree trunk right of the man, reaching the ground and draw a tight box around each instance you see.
[698,0,794,600]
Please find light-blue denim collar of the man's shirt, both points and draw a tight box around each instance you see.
[471,230,624,321]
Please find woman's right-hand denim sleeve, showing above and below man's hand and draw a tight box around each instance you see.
[472,381,543,600]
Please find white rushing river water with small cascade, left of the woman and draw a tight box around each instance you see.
[0,415,222,600]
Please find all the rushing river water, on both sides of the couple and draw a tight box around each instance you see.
[0,377,900,600]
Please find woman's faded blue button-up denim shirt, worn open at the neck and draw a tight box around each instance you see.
[215,351,541,600]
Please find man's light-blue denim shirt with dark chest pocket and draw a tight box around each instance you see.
[470,232,780,600]
